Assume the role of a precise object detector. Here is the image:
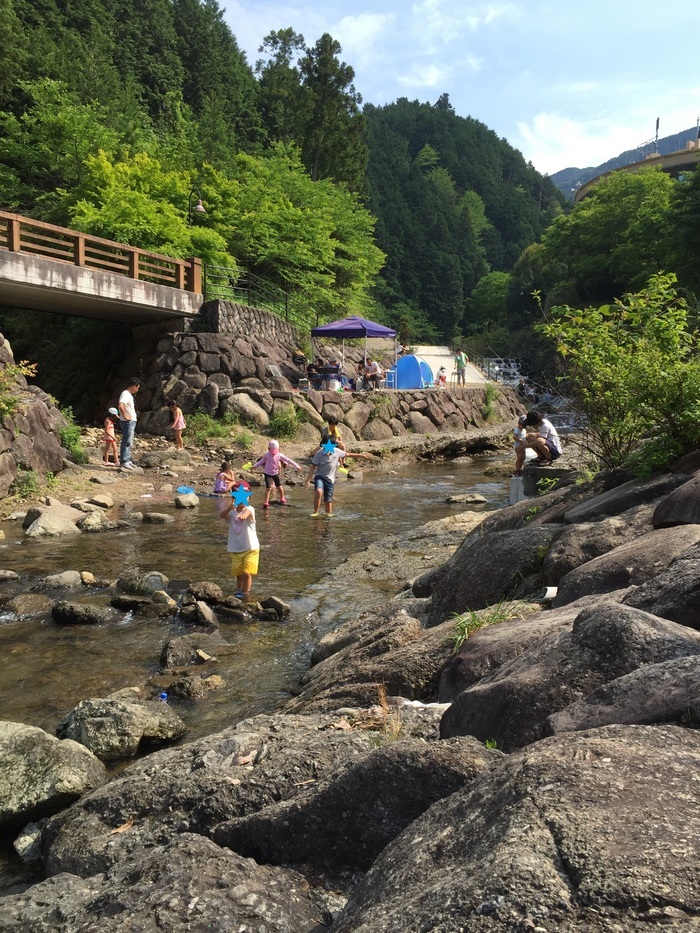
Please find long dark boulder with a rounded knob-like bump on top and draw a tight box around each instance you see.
[440,604,700,751]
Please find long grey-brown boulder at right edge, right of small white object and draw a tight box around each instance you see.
[554,525,700,606]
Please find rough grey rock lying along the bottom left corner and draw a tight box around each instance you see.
[2,833,320,933]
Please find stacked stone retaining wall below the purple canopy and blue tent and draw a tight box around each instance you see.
[117,301,522,441]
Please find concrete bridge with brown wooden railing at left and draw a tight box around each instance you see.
[0,211,204,329]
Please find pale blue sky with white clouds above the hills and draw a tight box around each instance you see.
[220,0,700,174]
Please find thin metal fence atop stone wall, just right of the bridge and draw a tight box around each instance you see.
[204,263,318,332]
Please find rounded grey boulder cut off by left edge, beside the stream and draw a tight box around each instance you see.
[0,722,107,829]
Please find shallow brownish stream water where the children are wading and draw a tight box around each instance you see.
[0,463,508,740]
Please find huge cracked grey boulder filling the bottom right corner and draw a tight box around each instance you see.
[331,726,700,933]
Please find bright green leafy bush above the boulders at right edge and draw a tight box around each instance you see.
[536,274,700,469]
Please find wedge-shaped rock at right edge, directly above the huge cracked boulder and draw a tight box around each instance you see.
[547,656,700,735]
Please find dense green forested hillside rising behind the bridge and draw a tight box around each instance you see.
[0,0,562,396]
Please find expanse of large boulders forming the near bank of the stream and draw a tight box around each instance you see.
[0,438,700,933]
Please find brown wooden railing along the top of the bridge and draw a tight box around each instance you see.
[0,211,202,294]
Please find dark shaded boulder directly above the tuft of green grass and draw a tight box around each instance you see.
[424,525,554,625]
